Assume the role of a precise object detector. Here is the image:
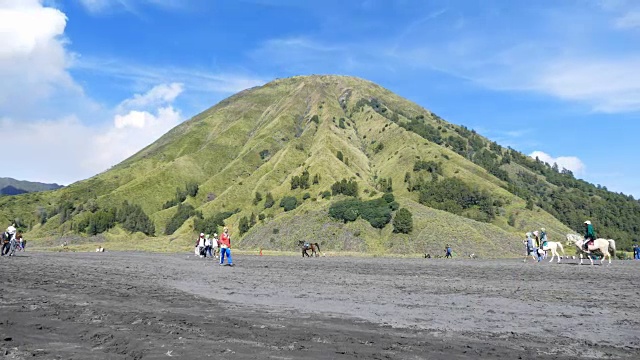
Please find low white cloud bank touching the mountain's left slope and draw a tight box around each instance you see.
[0,85,183,184]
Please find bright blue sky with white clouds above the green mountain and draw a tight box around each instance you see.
[0,0,640,198]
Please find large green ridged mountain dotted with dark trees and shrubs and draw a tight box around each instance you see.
[0,76,640,256]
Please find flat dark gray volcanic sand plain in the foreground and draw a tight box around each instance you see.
[0,252,640,359]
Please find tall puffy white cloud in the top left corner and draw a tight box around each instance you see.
[0,0,82,115]
